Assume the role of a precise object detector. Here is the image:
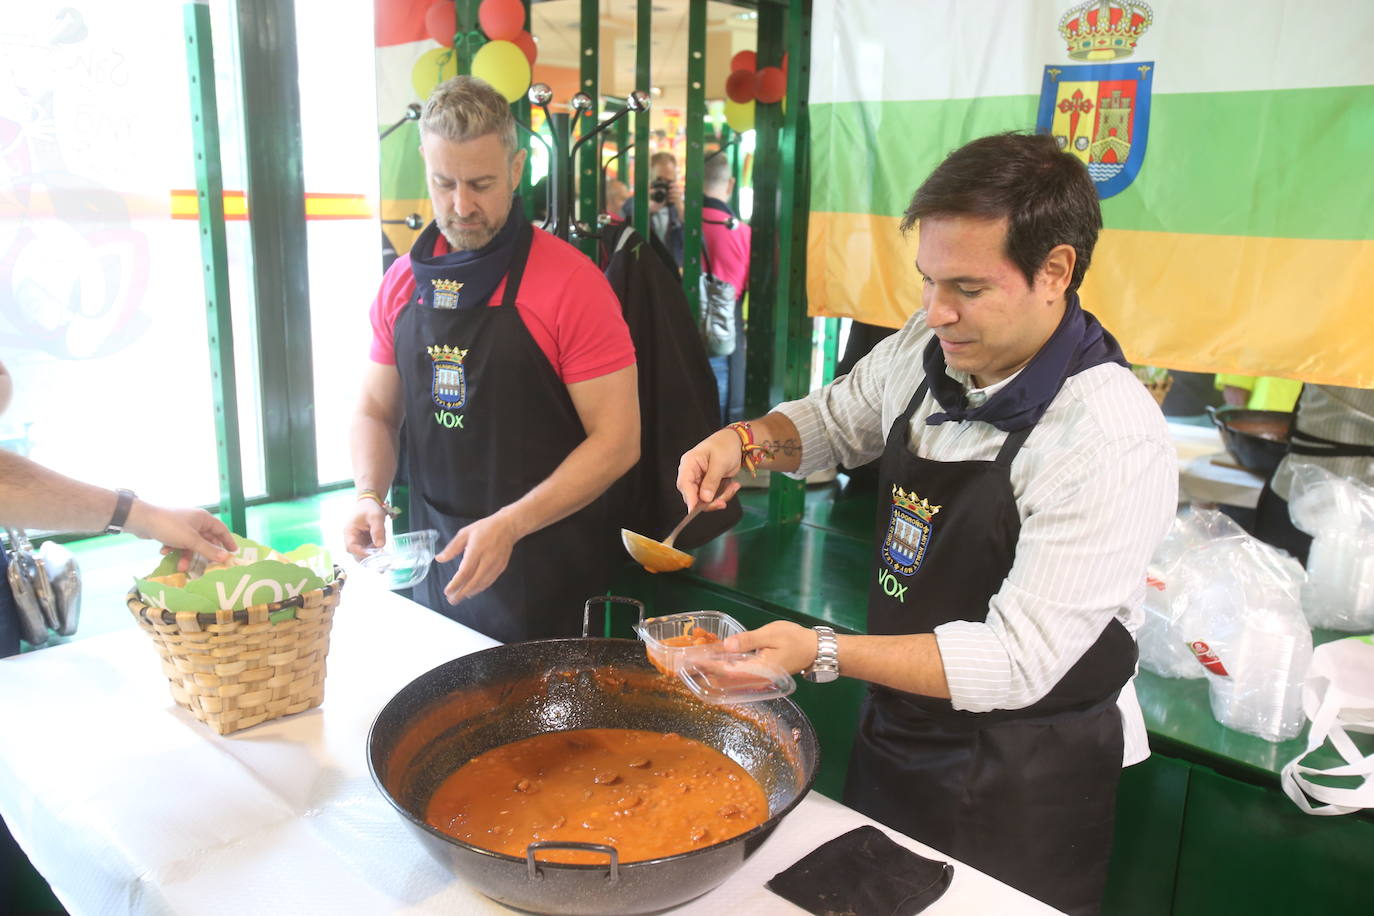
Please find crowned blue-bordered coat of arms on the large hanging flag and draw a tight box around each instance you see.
[1036,0,1154,199]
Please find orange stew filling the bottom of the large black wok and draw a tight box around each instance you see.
[425,728,768,864]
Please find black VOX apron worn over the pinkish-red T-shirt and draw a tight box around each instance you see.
[396,219,614,643]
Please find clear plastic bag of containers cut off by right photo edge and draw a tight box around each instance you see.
[1289,463,1374,633]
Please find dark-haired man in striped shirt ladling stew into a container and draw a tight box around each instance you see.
[677,133,1178,913]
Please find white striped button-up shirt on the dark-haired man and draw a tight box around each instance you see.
[776,312,1179,765]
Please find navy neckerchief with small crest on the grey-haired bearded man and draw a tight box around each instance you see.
[411,196,528,309]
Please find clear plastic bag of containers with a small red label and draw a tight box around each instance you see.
[1140,508,1312,742]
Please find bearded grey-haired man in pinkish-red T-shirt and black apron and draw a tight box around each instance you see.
[345,77,639,643]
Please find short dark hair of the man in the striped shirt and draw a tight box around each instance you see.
[901,133,1102,293]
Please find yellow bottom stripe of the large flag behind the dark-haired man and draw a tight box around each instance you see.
[807,213,1374,387]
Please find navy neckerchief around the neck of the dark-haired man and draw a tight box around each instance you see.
[925,293,1128,433]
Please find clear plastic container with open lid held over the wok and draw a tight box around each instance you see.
[635,611,797,703]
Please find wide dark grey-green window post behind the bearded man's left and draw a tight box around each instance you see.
[235,0,319,500]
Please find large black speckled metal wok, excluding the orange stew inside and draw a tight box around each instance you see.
[368,639,820,916]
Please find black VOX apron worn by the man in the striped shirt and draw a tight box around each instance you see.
[841,382,1136,913]
